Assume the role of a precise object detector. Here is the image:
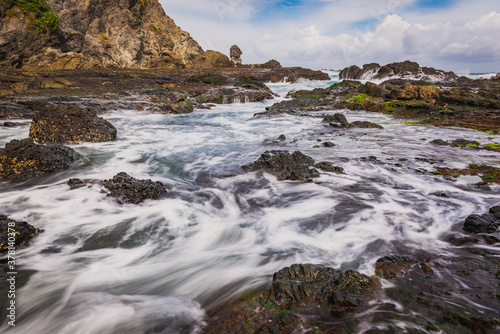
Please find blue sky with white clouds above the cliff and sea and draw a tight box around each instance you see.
[160,0,500,73]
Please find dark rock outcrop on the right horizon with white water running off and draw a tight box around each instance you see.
[339,60,458,82]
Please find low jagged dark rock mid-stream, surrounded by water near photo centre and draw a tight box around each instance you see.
[244,151,319,180]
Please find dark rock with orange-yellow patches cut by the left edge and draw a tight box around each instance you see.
[0,138,83,181]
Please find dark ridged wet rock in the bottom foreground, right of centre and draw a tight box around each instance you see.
[270,264,378,312]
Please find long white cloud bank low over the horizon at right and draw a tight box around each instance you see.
[255,12,500,67]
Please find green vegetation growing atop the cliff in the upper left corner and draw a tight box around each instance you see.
[0,0,59,34]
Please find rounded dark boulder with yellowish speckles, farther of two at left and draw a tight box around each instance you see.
[30,105,117,143]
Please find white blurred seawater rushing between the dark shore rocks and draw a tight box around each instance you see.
[0,74,500,334]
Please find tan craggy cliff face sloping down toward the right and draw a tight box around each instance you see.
[0,0,233,69]
